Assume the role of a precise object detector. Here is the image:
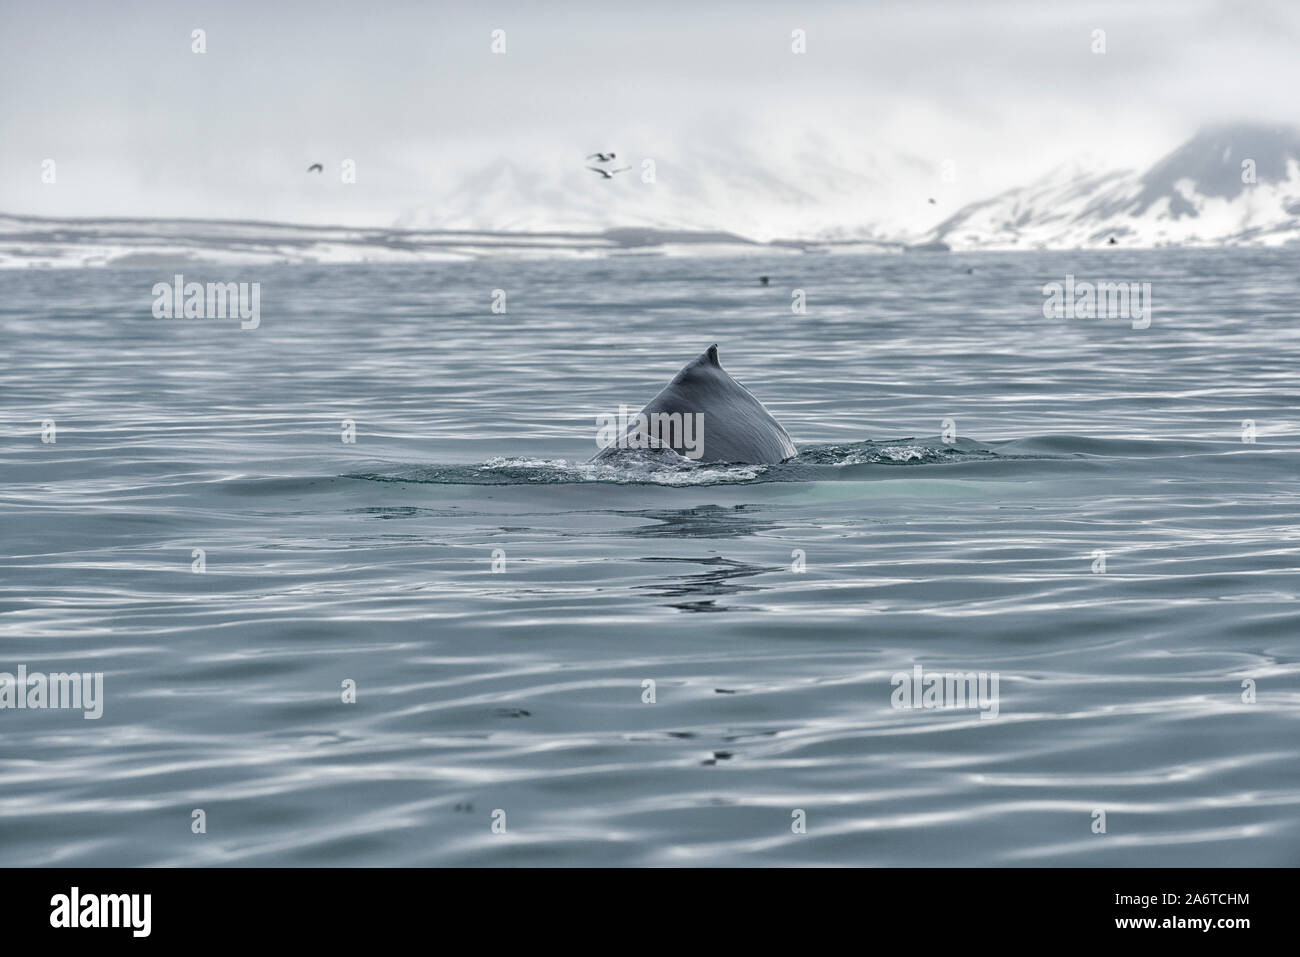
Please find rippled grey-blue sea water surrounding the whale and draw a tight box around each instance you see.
[0,250,1300,866]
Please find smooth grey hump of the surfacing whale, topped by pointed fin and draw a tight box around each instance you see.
[593,343,798,465]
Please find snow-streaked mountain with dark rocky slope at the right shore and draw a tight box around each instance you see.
[924,125,1300,250]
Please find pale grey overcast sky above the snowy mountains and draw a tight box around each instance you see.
[0,0,1300,225]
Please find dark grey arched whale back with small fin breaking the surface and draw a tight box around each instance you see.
[592,342,798,465]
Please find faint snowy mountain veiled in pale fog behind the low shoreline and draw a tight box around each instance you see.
[395,134,949,242]
